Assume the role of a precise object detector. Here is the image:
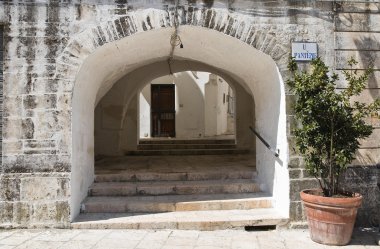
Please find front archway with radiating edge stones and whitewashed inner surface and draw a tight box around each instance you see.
[67,8,289,219]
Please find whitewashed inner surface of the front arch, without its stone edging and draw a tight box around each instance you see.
[70,26,289,219]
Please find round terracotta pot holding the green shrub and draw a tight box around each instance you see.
[301,189,362,246]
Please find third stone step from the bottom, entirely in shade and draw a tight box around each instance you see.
[89,179,260,196]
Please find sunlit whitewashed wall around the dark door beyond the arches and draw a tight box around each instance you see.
[139,71,229,139]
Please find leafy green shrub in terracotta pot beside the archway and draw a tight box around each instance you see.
[287,58,380,245]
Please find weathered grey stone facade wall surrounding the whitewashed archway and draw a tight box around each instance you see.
[0,0,380,227]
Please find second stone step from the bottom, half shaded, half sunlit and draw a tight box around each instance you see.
[82,193,273,213]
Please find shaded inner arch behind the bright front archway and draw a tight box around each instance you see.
[95,60,254,156]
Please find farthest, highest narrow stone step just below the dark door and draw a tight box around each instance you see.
[139,138,236,144]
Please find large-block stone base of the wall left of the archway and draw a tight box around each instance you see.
[0,173,70,228]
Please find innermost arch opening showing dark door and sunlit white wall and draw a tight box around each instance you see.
[138,71,238,139]
